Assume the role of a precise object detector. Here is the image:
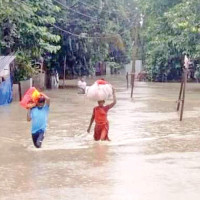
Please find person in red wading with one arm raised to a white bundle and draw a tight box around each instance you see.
[87,88,117,141]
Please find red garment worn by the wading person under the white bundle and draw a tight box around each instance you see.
[93,106,110,140]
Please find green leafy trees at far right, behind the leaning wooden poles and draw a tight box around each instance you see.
[140,0,200,81]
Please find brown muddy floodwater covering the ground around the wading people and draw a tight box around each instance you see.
[0,76,200,200]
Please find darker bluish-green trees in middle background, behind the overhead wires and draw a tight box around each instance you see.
[49,0,139,76]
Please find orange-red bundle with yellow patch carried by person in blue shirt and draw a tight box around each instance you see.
[20,87,41,109]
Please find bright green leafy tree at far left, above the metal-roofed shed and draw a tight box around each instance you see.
[0,0,60,80]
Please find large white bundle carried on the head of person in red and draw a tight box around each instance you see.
[86,82,112,101]
